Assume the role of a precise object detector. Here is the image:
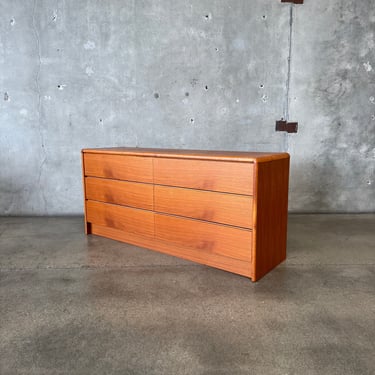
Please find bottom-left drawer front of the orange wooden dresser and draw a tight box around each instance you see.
[86,200,154,237]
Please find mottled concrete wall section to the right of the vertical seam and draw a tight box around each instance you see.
[288,0,375,212]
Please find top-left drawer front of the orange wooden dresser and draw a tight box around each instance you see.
[84,153,153,183]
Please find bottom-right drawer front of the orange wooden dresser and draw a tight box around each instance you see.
[155,214,252,261]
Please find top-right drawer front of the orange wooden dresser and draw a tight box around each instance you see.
[154,158,253,195]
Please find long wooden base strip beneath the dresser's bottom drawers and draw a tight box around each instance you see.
[92,224,251,277]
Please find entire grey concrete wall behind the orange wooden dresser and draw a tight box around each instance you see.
[0,0,375,215]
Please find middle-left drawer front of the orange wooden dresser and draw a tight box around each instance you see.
[85,177,153,210]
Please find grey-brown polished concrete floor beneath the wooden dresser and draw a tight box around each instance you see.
[0,215,375,375]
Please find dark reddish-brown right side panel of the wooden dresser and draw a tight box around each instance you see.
[252,157,289,281]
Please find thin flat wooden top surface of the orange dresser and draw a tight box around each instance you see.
[82,147,289,163]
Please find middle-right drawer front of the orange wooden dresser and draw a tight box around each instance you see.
[154,185,253,228]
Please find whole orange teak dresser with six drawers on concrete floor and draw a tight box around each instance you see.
[82,148,289,281]
